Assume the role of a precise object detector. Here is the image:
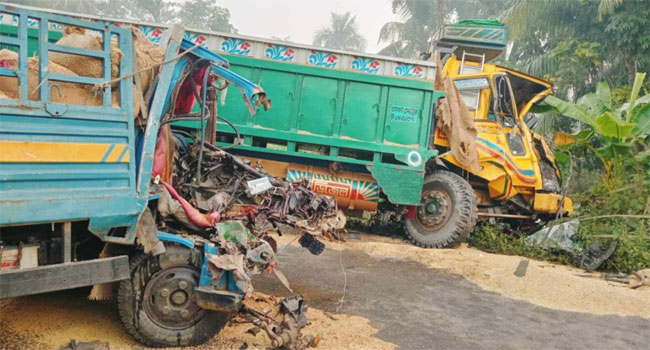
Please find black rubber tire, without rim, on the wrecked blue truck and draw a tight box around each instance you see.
[117,244,230,347]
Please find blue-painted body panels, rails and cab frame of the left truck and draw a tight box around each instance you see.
[0,5,248,310]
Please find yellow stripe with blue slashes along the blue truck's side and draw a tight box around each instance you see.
[0,141,129,163]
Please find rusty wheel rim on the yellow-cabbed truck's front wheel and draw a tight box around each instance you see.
[416,189,452,235]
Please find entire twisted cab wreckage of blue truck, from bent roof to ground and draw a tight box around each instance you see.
[135,35,345,348]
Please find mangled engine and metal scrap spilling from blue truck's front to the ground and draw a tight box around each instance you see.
[148,125,344,349]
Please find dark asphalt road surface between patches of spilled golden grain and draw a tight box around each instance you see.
[258,247,650,350]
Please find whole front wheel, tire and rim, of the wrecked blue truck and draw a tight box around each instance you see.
[117,245,230,347]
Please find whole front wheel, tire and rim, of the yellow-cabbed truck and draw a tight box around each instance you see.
[406,170,478,248]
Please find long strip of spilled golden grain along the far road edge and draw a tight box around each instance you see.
[277,234,650,319]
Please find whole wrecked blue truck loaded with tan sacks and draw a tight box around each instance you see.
[0,5,339,347]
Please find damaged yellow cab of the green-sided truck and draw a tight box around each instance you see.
[434,47,573,219]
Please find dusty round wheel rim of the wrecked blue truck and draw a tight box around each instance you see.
[143,266,204,329]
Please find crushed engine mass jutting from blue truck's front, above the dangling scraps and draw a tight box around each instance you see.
[159,141,342,245]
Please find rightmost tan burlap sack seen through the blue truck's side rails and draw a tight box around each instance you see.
[49,26,124,79]
